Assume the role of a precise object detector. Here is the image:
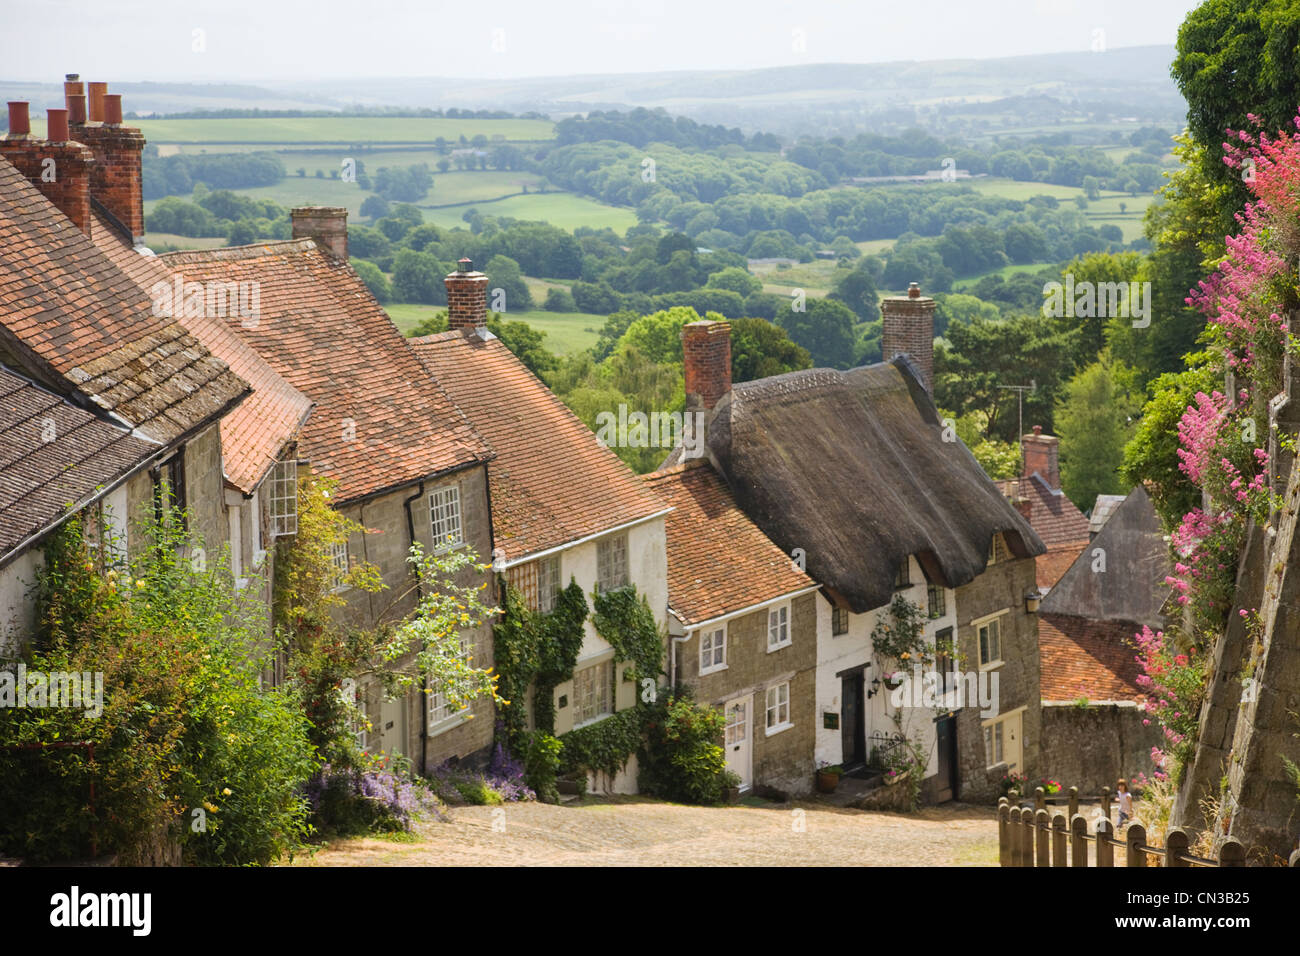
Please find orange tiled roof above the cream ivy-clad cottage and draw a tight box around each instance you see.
[408,330,664,561]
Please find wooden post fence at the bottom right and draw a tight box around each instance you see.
[997,787,1242,866]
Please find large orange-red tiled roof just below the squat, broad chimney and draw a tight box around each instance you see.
[159,239,491,502]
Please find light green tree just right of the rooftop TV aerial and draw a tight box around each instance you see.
[1056,355,1139,510]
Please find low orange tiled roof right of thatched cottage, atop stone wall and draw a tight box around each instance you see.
[1039,614,1145,701]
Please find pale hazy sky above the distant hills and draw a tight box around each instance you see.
[0,0,1197,82]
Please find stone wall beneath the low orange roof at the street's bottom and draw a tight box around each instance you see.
[1036,701,1162,796]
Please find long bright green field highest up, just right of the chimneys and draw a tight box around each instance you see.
[100,116,555,144]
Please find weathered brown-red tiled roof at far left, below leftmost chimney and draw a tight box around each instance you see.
[0,159,248,442]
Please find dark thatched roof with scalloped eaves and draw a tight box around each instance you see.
[707,356,1045,613]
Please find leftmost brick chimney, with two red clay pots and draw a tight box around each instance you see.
[0,101,95,235]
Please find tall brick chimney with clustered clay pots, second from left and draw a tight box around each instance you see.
[64,79,144,239]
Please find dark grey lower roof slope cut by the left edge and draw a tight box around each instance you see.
[0,365,164,562]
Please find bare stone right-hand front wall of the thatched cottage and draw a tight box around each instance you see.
[957,548,1041,803]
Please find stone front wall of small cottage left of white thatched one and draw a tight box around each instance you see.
[673,593,820,793]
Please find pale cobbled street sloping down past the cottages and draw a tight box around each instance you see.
[295,797,997,866]
